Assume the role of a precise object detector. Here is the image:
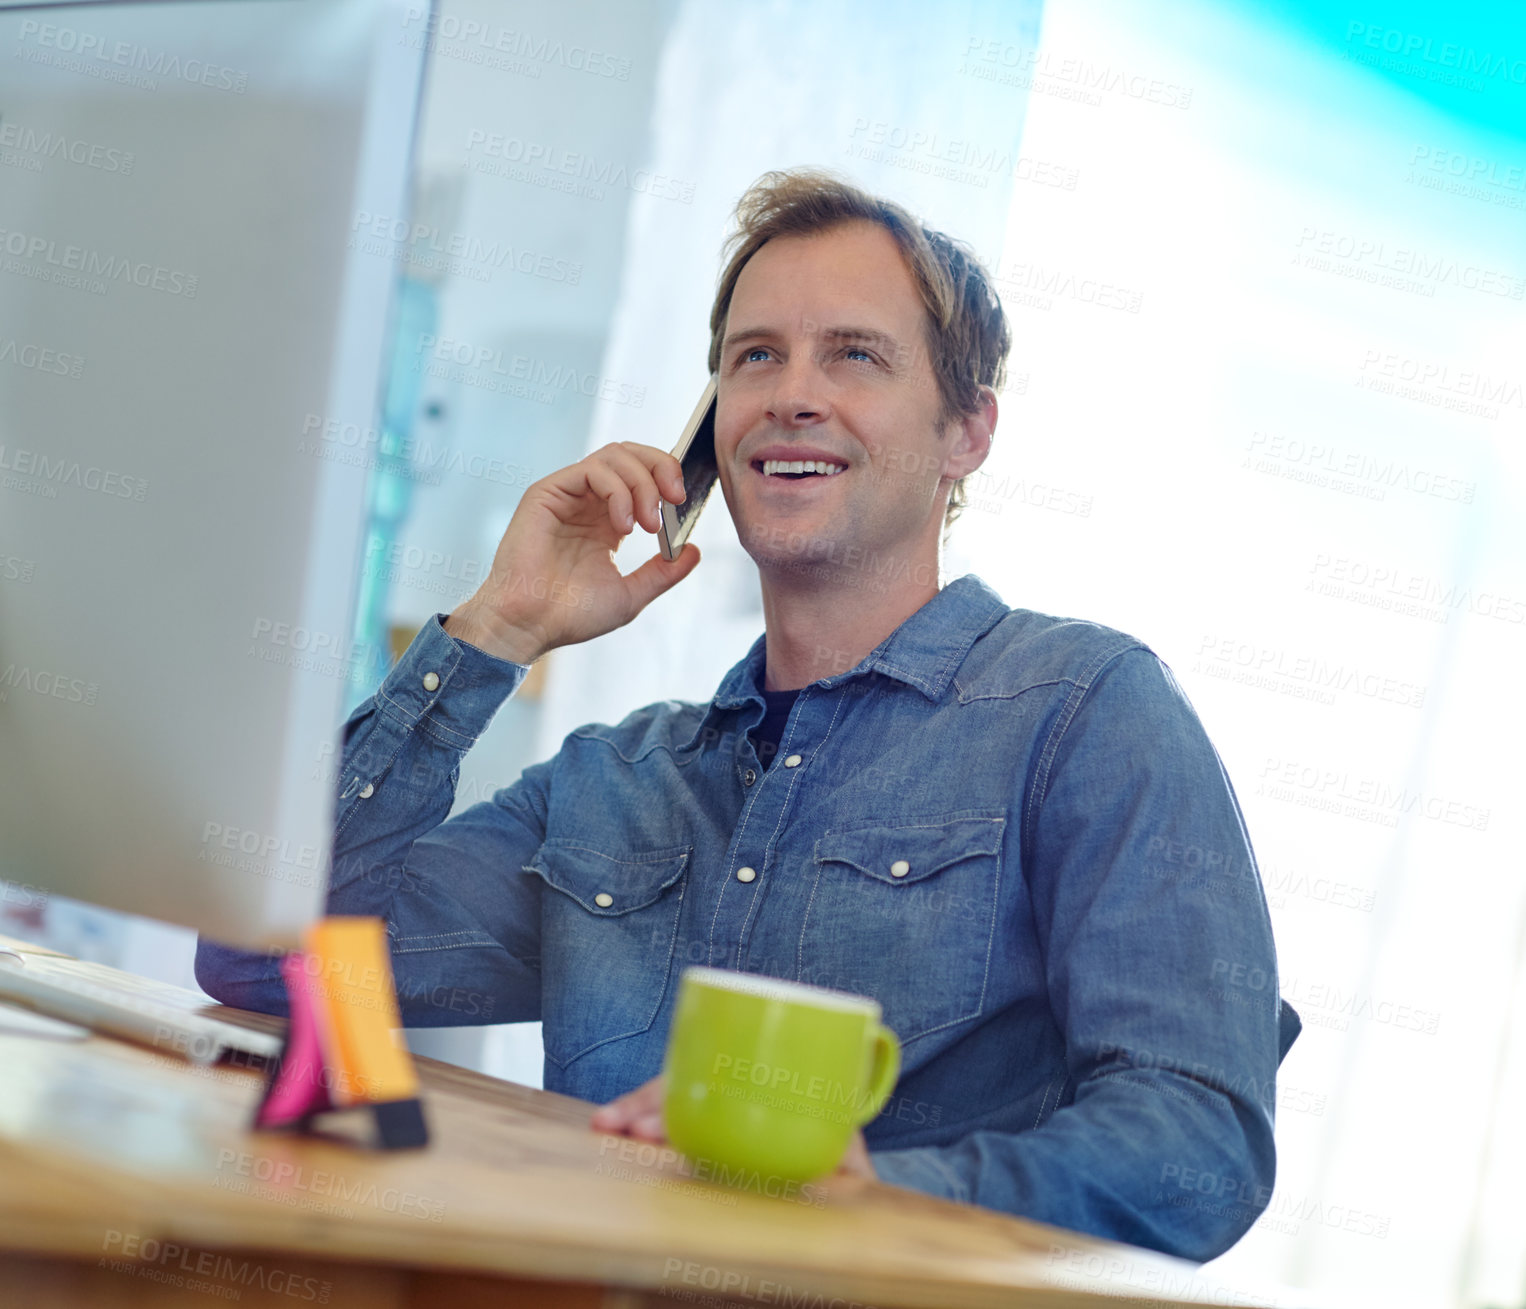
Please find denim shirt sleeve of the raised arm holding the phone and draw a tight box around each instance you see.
[195,615,548,1027]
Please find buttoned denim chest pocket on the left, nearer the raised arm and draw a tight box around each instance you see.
[525,841,693,1068]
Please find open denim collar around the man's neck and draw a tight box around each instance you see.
[681,572,1007,749]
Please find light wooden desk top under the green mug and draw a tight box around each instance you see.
[0,939,1296,1309]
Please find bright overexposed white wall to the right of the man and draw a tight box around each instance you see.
[960,0,1526,1304]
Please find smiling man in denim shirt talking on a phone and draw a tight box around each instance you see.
[197,172,1293,1259]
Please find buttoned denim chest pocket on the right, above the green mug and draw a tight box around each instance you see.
[797,812,1006,1044]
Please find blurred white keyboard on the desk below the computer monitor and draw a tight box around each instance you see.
[0,949,282,1065]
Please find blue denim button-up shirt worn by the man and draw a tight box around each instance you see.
[197,575,1296,1259]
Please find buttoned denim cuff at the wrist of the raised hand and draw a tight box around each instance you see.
[377,613,530,749]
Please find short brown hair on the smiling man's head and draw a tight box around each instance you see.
[710,168,1012,531]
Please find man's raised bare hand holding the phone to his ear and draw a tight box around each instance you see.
[444,441,699,664]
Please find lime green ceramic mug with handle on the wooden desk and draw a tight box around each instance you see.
[662,967,900,1185]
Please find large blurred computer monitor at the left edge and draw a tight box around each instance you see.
[0,0,427,947]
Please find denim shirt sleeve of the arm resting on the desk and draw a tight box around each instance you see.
[871,647,1296,1260]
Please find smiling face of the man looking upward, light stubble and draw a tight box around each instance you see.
[716,221,986,571]
